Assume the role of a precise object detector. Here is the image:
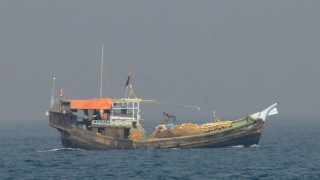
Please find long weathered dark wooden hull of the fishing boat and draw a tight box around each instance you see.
[49,112,263,150]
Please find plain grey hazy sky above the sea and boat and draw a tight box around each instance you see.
[0,0,320,121]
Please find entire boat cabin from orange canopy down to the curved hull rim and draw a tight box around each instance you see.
[60,98,141,138]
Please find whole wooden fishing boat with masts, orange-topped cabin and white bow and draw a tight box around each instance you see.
[46,45,278,150]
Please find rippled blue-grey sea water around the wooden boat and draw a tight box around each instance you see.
[0,117,320,179]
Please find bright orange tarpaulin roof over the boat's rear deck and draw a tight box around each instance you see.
[70,98,112,109]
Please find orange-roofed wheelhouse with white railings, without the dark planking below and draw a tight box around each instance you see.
[60,98,142,127]
